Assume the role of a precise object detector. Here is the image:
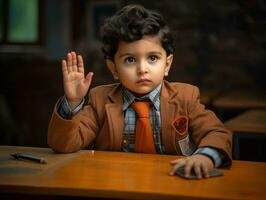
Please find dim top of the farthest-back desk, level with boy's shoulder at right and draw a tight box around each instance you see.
[213,91,266,109]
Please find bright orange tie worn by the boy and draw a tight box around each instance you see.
[132,101,156,154]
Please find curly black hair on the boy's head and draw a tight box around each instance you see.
[101,5,175,60]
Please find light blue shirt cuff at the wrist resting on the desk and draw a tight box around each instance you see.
[193,147,224,168]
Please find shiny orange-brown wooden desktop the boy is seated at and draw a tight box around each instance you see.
[0,146,266,200]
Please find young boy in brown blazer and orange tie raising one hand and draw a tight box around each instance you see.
[48,5,231,179]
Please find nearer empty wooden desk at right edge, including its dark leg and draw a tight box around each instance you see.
[224,110,266,159]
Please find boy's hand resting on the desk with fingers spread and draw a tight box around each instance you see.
[170,154,214,179]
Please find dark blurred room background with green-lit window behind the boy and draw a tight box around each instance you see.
[0,0,266,159]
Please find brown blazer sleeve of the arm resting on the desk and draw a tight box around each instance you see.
[188,86,232,166]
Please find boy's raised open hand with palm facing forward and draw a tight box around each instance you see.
[62,51,93,108]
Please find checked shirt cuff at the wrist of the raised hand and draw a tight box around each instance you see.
[58,96,84,119]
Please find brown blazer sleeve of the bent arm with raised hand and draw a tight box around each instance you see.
[47,94,99,153]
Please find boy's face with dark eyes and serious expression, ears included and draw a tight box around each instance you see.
[107,36,173,95]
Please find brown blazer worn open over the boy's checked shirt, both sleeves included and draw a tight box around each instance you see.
[48,81,232,165]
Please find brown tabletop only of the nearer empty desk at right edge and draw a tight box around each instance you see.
[225,110,266,135]
